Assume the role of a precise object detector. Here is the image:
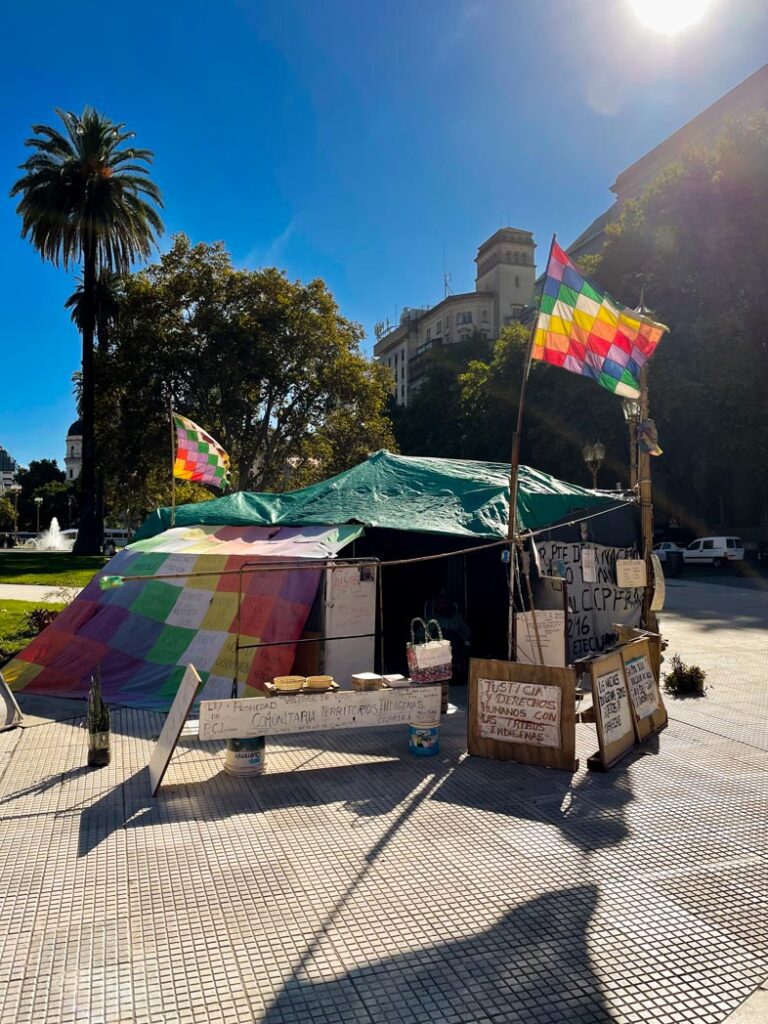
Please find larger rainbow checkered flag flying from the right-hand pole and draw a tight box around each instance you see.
[531,242,668,398]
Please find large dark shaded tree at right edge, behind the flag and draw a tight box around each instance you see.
[590,114,768,526]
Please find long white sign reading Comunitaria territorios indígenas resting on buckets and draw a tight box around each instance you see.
[200,686,440,739]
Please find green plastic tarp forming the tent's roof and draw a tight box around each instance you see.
[133,451,625,541]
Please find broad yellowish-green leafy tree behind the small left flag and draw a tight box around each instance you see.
[98,236,394,508]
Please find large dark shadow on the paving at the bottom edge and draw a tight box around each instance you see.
[262,885,613,1024]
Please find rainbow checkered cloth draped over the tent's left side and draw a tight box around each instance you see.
[3,526,361,711]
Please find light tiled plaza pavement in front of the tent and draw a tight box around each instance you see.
[0,582,768,1024]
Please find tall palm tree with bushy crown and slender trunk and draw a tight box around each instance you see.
[10,106,163,554]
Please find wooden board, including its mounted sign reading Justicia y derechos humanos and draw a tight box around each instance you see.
[467,658,579,771]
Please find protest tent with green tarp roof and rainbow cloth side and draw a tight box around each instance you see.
[4,452,637,710]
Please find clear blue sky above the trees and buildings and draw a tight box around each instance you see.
[0,0,768,464]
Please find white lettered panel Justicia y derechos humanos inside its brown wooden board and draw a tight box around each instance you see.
[477,679,561,748]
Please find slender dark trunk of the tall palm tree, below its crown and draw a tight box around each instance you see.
[74,244,103,555]
